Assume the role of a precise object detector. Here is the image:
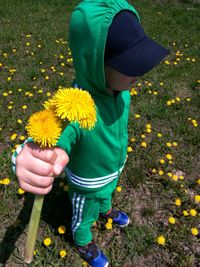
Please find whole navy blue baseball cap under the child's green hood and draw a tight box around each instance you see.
[104,11,169,77]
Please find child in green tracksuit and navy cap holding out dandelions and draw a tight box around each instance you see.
[13,0,169,267]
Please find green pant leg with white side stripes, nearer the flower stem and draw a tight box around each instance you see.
[70,192,100,246]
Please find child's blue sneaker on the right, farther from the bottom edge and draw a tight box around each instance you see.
[101,208,130,227]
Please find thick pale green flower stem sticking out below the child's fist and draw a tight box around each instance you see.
[24,195,44,263]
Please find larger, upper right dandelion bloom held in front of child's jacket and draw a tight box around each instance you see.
[44,88,96,129]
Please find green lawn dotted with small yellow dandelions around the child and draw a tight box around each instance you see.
[0,0,200,267]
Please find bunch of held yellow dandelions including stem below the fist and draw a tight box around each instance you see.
[25,88,96,263]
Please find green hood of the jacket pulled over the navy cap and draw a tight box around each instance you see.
[69,0,139,96]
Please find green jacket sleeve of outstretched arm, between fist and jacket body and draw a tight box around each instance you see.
[56,123,81,155]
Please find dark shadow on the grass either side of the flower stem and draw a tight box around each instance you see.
[0,181,73,266]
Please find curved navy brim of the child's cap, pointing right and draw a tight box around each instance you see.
[105,36,169,77]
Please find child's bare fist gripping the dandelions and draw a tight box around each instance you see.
[16,143,69,195]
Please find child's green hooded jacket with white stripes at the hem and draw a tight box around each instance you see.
[57,0,139,197]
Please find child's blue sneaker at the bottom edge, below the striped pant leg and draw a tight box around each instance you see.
[76,242,108,267]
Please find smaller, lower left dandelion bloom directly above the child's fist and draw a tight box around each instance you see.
[26,110,62,147]
